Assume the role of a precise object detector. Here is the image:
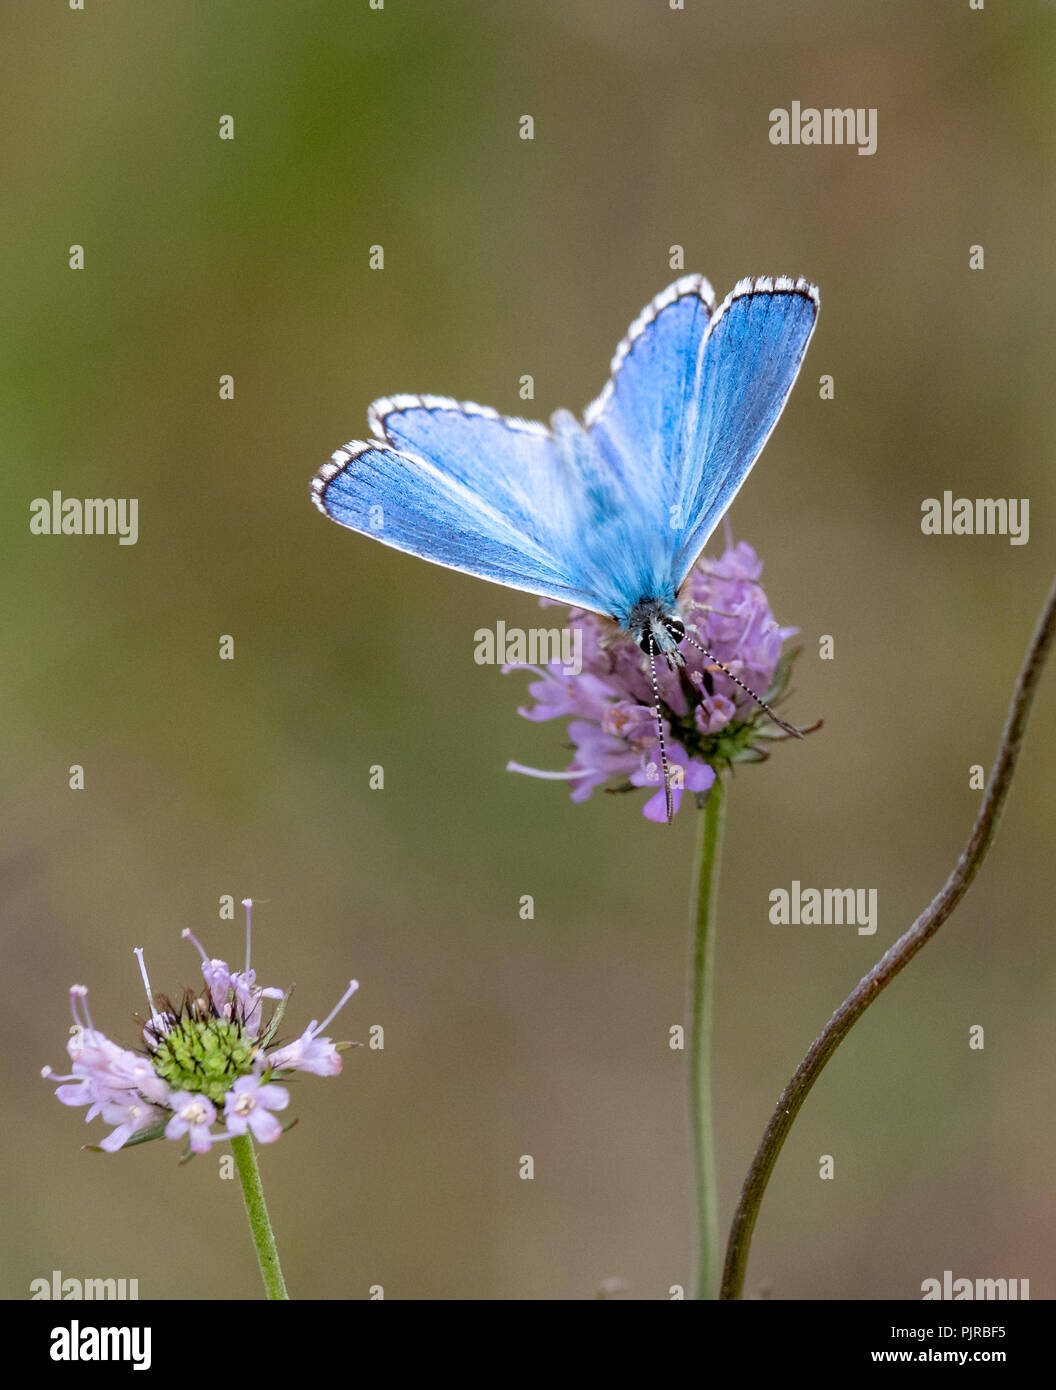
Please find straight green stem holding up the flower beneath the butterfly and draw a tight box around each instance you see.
[689,774,725,1298]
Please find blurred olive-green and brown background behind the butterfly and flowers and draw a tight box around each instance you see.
[0,0,1056,1298]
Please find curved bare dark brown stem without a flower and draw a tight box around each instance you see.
[718,569,1056,1298]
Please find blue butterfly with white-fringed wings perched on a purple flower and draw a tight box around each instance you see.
[311,275,818,817]
